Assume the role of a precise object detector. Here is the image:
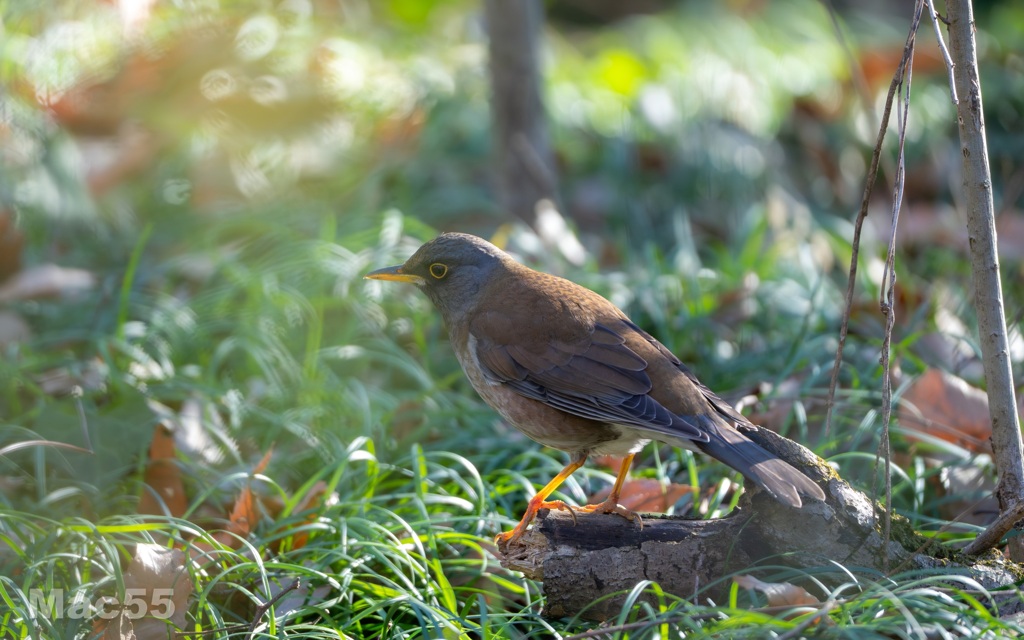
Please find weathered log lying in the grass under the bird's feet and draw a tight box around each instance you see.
[501,429,1021,621]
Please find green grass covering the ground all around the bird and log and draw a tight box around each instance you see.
[0,1,1021,639]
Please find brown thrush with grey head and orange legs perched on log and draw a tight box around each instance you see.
[365,232,824,548]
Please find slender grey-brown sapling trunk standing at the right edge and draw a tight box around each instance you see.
[946,0,1024,561]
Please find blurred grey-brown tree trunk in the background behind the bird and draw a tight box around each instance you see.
[484,0,556,226]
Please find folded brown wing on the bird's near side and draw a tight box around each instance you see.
[469,311,708,441]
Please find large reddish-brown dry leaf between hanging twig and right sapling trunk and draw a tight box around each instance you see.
[898,369,992,453]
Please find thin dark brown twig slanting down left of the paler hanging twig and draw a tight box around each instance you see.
[825,4,921,433]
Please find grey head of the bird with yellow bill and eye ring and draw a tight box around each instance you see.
[366,233,515,326]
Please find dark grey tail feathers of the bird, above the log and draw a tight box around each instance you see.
[691,419,825,508]
